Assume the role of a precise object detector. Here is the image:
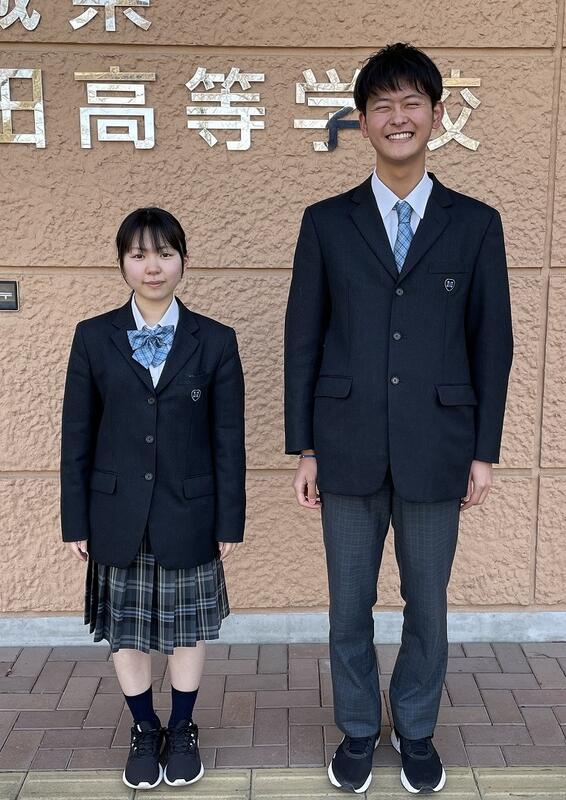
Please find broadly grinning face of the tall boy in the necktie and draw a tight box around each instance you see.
[360,85,443,171]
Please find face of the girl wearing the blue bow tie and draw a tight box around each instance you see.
[122,237,184,304]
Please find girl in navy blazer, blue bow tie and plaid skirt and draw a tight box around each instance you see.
[61,208,245,789]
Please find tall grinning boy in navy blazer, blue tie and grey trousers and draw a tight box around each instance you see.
[285,43,513,793]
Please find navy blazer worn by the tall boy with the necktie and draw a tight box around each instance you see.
[285,175,513,502]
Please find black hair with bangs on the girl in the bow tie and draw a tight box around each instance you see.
[116,206,187,272]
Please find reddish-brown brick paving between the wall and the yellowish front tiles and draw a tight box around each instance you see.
[0,643,566,772]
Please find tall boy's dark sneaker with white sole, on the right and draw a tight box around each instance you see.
[391,728,446,794]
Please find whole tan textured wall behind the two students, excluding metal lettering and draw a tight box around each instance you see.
[0,0,566,615]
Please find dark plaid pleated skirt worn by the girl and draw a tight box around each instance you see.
[85,537,230,655]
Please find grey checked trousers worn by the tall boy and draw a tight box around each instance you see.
[322,476,460,739]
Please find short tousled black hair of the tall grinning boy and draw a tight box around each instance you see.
[354,42,442,114]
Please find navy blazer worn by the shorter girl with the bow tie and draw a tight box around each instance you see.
[61,300,245,568]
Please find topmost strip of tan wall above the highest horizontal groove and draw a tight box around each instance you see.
[2,0,561,51]
